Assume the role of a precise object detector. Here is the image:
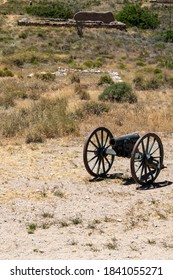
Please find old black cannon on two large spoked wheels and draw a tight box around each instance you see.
[83,127,164,185]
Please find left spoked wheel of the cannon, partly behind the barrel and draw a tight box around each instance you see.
[83,127,114,177]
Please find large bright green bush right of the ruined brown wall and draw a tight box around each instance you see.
[115,3,159,29]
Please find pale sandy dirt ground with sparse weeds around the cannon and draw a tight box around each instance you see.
[0,134,173,259]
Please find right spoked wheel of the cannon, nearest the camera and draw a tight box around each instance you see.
[130,133,164,185]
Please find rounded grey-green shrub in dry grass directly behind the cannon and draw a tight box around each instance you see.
[99,82,137,103]
